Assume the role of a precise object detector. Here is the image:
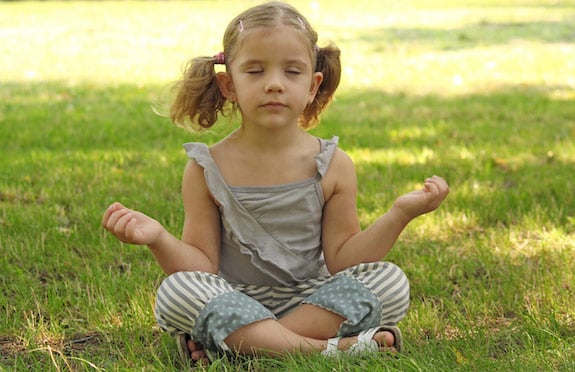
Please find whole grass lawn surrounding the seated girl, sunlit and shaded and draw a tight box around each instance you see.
[0,0,575,371]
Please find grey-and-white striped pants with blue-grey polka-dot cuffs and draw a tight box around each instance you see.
[155,262,409,352]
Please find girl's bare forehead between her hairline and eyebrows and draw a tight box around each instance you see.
[234,26,313,63]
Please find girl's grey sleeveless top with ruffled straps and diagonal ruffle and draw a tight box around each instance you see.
[184,137,338,286]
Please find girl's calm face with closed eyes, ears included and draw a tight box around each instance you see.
[218,26,323,128]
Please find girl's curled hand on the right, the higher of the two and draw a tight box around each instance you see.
[393,176,449,220]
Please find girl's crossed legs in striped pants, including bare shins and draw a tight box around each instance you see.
[156,263,409,360]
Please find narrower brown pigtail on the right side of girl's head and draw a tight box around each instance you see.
[300,43,341,129]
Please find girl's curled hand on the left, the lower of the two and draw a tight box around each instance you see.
[102,203,164,245]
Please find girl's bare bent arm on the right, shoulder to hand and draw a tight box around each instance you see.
[322,152,449,273]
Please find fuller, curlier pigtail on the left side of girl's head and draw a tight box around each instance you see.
[170,57,226,129]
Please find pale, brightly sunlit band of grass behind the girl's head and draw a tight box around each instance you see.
[0,1,575,95]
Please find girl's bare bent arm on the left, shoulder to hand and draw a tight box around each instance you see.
[102,162,220,274]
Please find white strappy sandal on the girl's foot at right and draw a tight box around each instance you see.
[321,326,403,356]
